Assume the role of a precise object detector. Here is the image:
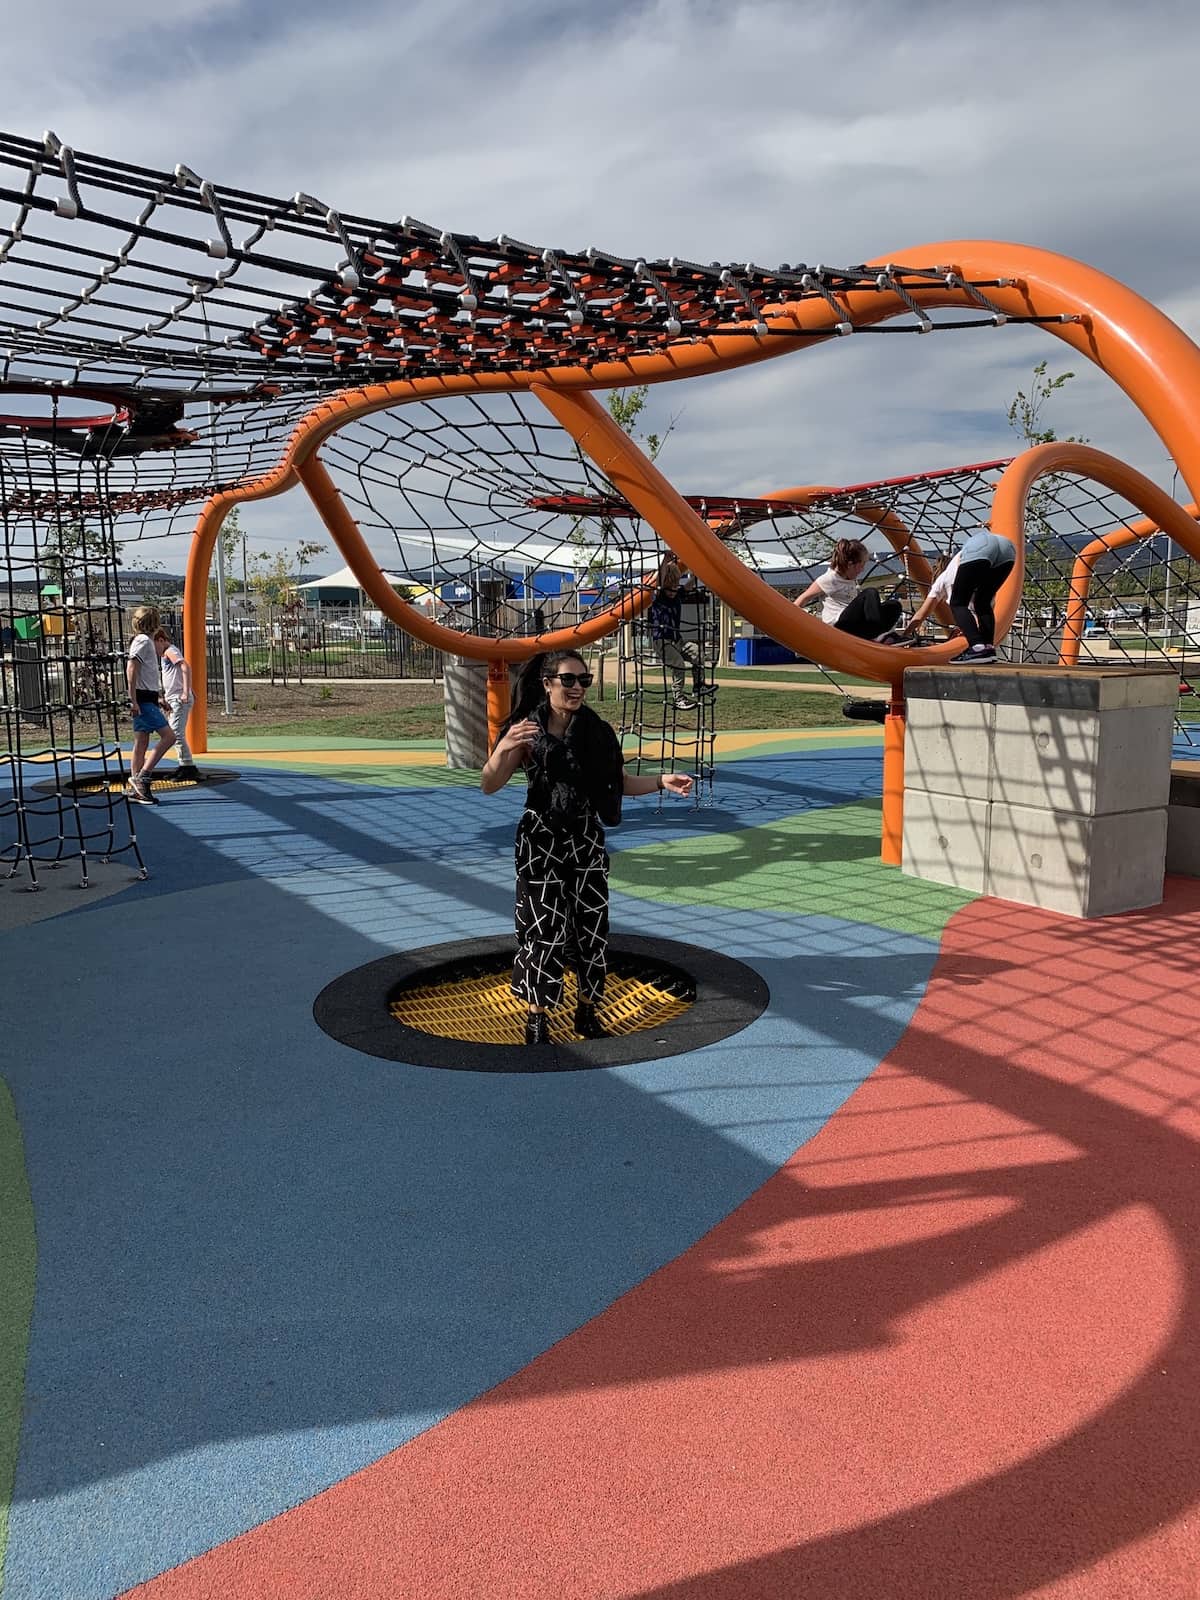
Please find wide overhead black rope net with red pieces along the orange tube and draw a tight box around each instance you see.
[0,123,1069,588]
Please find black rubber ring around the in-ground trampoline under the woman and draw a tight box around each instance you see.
[312,934,771,1072]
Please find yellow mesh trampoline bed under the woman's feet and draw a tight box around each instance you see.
[389,968,693,1045]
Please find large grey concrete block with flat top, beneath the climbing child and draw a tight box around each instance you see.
[904,666,1179,917]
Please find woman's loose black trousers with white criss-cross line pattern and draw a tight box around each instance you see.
[512,811,608,1006]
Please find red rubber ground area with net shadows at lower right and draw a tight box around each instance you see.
[134,880,1200,1600]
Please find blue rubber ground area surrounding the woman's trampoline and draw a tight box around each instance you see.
[0,749,936,1600]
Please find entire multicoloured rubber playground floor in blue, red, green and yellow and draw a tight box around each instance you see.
[0,730,1200,1600]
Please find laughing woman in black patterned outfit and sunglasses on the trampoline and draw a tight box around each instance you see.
[480,651,691,1045]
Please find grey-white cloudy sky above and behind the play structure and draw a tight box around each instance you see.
[3,0,1200,570]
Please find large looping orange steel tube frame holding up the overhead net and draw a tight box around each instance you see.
[186,240,1200,864]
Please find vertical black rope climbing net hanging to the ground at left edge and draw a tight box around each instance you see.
[0,405,146,888]
